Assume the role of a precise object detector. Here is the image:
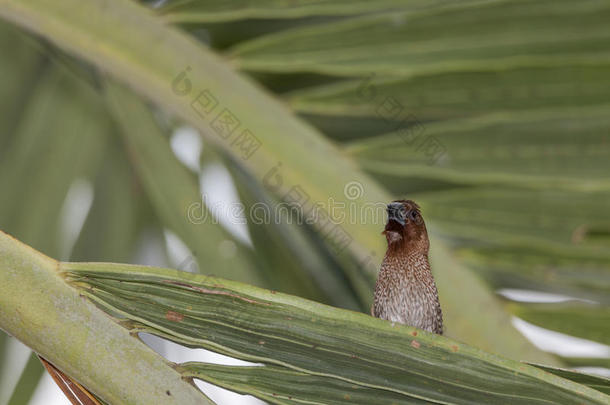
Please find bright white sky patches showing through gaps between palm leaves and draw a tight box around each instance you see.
[0,127,610,405]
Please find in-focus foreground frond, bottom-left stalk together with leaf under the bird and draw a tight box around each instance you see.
[0,229,608,404]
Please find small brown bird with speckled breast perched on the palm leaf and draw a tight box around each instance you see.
[371,200,443,334]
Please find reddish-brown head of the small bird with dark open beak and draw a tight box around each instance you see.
[383,200,430,253]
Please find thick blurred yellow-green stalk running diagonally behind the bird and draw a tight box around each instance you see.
[0,0,553,363]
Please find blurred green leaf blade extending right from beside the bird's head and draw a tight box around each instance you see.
[419,187,610,252]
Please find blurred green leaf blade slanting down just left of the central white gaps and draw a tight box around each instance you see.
[106,84,264,285]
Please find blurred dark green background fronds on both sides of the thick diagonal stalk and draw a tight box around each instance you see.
[0,0,610,403]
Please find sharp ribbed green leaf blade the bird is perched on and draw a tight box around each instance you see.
[62,263,607,404]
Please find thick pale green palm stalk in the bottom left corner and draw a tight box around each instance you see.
[0,232,213,405]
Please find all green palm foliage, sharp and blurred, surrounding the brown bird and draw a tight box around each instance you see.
[0,0,610,404]
